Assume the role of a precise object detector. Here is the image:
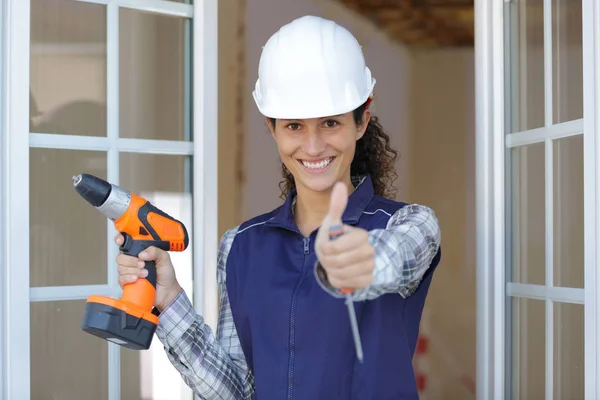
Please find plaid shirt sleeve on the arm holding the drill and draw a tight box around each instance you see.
[156,227,254,400]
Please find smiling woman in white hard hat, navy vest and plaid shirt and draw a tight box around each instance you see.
[116,16,440,400]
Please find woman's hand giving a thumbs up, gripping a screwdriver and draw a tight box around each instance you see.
[315,182,375,289]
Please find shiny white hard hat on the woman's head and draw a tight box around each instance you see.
[252,16,375,119]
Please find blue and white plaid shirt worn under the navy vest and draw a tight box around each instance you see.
[156,190,440,400]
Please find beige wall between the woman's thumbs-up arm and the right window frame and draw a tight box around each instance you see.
[407,49,475,399]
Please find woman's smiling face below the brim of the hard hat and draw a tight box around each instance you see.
[267,110,370,192]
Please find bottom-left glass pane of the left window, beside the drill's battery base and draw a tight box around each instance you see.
[31,302,108,400]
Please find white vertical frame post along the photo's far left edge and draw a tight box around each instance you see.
[0,0,30,399]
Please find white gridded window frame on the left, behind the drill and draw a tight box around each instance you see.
[0,0,218,400]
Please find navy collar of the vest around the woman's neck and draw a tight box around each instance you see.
[266,175,374,231]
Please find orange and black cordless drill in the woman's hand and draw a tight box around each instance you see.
[73,174,189,350]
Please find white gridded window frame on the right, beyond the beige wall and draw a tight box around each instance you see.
[475,0,600,399]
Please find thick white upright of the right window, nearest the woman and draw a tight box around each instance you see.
[475,0,505,400]
